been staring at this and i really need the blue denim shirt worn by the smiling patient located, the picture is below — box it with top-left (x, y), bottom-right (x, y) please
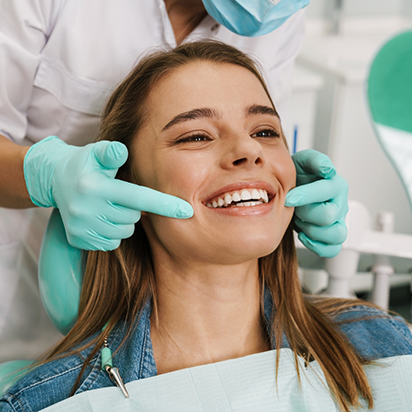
top-left (0, 293), bottom-right (412, 412)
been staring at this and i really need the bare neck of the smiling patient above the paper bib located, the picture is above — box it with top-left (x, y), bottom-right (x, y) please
top-left (151, 261), bottom-right (270, 374)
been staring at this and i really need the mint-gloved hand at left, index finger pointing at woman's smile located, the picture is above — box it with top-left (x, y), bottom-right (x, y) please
top-left (24, 136), bottom-right (193, 250)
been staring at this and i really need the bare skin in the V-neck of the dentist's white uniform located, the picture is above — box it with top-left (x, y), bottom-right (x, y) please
top-left (164, 0), bottom-right (207, 44)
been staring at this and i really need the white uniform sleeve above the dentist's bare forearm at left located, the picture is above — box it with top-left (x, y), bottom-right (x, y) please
top-left (0, 0), bottom-right (64, 143)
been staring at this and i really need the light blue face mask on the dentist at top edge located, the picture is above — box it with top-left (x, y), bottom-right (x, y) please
top-left (202, 0), bottom-right (310, 37)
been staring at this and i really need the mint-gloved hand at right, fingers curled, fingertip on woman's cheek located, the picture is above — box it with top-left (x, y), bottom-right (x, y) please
top-left (285, 150), bottom-right (349, 257)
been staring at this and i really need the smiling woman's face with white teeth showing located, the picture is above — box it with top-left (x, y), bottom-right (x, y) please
top-left (132, 62), bottom-right (295, 264)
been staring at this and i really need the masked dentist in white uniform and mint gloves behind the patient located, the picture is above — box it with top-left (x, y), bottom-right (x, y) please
top-left (0, 0), bottom-right (348, 362)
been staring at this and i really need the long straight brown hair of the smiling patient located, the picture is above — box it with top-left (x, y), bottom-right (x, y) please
top-left (47, 41), bottom-right (373, 411)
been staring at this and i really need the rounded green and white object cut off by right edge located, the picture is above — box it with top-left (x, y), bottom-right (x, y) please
top-left (366, 29), bottom-right (412, 212)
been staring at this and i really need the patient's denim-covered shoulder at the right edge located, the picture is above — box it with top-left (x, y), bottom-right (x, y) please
top-left (333, 304), bottom-right (412, 360)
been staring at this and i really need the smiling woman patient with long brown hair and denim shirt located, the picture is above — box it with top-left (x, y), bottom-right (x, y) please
top-left (0, 42), bottom-right (412, 411)
